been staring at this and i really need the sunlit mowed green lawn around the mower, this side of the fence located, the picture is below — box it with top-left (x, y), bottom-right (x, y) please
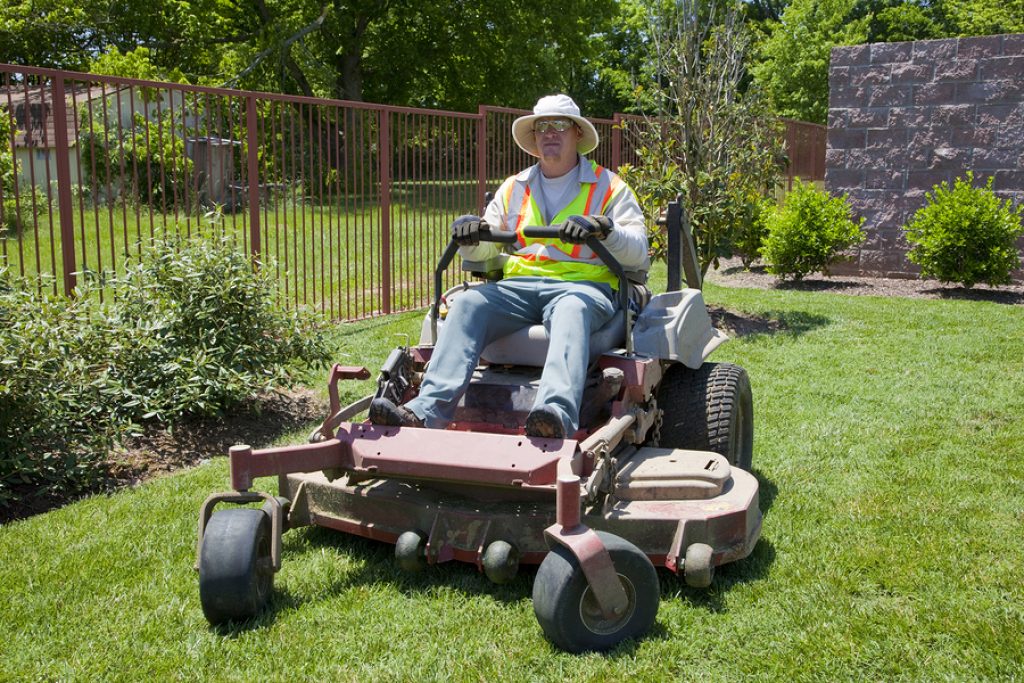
top-left (0, 285), bottom-right (1024, 681)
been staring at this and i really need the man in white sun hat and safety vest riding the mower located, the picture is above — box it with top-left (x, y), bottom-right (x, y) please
top-left (370, 95), bottom-right (650, 438)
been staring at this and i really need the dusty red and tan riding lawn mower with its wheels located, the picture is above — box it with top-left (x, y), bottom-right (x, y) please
top-left (196, 200), bottom-right (761, 651)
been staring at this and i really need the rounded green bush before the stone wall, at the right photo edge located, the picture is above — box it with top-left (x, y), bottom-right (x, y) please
top-left (903, 171), bottom-right (1024, 288)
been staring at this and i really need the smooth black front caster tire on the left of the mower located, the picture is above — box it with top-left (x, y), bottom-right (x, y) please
top-left (199, 508), bottom-right (273, 626)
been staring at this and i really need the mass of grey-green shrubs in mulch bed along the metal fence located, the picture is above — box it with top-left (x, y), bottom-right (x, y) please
top-left (0, 238), bottom-right (328, 506)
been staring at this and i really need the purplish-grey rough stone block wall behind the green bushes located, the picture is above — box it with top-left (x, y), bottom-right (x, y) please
top-left (825, 35), bottom-right (1024, 280)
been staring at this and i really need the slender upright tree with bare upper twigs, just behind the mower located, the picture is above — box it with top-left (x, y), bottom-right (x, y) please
top-left (624, 0), bottom-right (782, 272)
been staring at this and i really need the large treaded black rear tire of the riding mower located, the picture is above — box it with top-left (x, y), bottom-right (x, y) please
top-left (657, 362), bottom-right (754, 471)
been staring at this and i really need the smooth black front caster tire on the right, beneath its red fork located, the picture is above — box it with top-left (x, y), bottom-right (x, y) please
top-left (534, 531), bottom-right (660, 652)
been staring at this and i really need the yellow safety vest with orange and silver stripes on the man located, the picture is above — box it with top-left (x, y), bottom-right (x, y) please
top-left (499, 162), bottom-right (626, 290)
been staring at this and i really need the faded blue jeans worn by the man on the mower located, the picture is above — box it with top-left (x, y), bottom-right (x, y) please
top-left (406, 278), bottom-right (616, 434)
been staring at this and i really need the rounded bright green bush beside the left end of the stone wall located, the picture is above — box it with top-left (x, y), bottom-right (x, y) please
top-left (761, 180), bottom-right (864, 280)
